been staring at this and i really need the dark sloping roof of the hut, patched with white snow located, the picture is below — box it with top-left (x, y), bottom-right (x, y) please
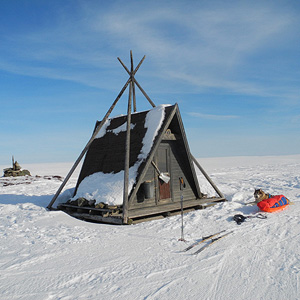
top-left (73, 105), bottom-right (169, 205)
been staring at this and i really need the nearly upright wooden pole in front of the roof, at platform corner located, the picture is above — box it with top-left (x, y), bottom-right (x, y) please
top-left (123, 82), bottom-right (132, 224)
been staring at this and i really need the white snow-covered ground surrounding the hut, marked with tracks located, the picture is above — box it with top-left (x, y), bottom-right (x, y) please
top-left (0, 155), bottom-right (300, 300)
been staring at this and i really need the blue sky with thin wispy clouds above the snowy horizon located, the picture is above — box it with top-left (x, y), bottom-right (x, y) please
top-left (0, 0), bottom-right (300, 165)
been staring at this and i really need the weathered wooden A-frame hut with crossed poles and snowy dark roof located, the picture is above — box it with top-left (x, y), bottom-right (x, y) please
top-left (48, 53), bottom-right (225, 224)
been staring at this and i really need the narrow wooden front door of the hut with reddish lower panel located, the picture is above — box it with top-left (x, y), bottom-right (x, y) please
top-left (157, 144), bottom-right (171, 202)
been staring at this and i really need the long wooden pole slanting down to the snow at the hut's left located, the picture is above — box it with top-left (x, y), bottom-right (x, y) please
top-left (47, 78), bottom-right (131, 209)
